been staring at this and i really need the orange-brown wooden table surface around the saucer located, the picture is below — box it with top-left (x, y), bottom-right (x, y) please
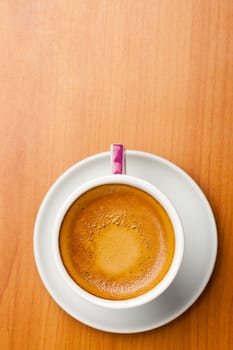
top-left (0, 0), bottom-right (233, 350)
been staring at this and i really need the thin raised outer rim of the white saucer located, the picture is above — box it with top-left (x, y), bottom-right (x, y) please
top-left (33, 150), bottom-right (218, 334)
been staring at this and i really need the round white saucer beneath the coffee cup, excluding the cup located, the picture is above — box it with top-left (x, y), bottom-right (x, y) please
top-left (34, 151), bottom-right (217, 333)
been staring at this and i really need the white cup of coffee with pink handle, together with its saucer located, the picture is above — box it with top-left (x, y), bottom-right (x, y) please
top-left (34, 144), bottom-right (217, 333)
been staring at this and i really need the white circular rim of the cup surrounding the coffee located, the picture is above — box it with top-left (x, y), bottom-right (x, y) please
top-left (52, 174), bottom-right (184, 309)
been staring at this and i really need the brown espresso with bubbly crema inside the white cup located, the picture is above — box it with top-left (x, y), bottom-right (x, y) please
top-left (58, 183), bottom-right (175, 300)
